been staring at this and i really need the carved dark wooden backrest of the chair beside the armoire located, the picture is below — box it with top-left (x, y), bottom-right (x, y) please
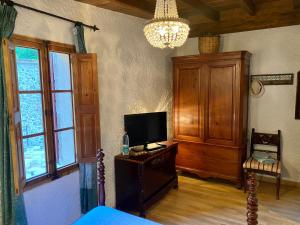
top-left (250, 128), bottom-right (281, 160)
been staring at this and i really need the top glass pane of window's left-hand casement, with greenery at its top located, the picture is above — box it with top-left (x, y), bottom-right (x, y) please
top-left (16, 47), bottom-right (41, 91)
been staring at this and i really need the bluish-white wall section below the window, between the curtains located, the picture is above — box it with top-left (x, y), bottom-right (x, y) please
top-left (24, 172), bottom-right (81, 225)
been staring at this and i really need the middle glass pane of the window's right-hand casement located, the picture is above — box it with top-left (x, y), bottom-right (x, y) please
top-left (52, 93), bottom-right (73, 129)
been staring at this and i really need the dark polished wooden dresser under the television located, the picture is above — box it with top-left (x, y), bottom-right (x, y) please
top-left (115, 142), bottom-right (178, 217)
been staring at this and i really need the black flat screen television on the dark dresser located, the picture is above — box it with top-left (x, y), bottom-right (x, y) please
top-left (124, 112), bottom-right (167, 149)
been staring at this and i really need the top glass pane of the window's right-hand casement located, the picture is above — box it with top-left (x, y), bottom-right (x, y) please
top-left (50, 52), bottom-right (71, 90)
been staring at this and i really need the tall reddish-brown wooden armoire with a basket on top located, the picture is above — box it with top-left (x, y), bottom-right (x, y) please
top-left (173, 51), bottom-right (251, 184)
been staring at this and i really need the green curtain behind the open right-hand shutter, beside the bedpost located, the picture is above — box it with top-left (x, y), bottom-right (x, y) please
top-left (74, 22), bottom-right (98, 213)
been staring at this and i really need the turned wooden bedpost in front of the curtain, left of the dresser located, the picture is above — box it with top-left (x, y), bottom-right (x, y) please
top-left (97, 149), bottom-right (105, 205)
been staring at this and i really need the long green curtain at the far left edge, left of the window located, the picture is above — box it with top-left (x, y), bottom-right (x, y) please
top-left (0, 5), bottom-right (27, 225)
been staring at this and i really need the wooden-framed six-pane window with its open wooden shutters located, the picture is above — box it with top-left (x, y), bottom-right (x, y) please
top-left (2, 35), bottom-right (100, 190)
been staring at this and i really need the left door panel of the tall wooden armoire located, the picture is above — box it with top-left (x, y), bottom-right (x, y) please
top-left (175, 65), bottom-right (203, 141)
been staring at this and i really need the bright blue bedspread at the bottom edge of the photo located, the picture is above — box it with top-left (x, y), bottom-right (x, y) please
top-left (73, 206), bottom-right (161, 225)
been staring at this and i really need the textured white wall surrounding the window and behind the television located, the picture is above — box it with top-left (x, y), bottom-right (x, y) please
top-left (15, 0), bottom-right (172, 225)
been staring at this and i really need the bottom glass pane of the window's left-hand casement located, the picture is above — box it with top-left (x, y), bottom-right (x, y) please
top-left (23, 136), bottom-right (47, 180)
